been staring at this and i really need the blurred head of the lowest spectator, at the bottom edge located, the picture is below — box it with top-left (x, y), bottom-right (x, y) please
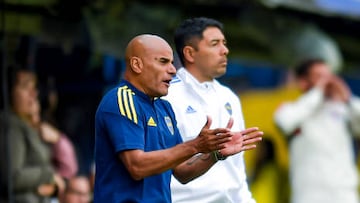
top-left (60, 176), bottom-right (92, 203)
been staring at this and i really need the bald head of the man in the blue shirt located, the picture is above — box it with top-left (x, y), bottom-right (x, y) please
top-left (124, 34), bottom-right (176, 97)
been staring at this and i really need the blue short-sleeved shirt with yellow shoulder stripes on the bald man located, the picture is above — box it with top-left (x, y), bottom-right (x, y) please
top-left (94, 80), bottom-right (182, 203)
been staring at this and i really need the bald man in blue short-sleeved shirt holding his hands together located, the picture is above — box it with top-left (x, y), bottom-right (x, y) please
top-left (94, 34), bottom-right (262, 203)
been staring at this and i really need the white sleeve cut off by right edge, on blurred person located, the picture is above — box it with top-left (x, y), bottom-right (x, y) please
top-left (348, 96), bottom-right (360, 137)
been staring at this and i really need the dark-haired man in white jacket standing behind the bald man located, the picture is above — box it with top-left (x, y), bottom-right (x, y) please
top-left (164, 17), bottom-right (255, 203)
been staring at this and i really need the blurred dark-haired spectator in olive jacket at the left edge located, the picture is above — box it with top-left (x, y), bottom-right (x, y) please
top-left (0, 67), bottom-right (64, 203)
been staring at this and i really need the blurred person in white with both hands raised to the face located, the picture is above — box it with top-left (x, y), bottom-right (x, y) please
top-left (274, 59), bottom-right (360, 203)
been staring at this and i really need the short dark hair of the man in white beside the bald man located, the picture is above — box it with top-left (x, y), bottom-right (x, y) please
top-left (174, 17), bottom-right (224, 64)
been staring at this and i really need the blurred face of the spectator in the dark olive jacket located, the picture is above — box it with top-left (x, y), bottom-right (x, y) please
top-left (11, 71), bottom-right (38, 119)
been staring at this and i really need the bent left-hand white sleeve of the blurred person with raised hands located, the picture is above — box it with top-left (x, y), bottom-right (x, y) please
top-left (274, 88), bottom-right (324, 135)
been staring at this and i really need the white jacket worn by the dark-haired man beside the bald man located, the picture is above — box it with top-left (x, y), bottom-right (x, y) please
top-left (164, 68), bottom-right (255, 203)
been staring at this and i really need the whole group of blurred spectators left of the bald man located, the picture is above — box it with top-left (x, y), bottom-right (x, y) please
top-left (0, 66), bottom-right (92, 203)
